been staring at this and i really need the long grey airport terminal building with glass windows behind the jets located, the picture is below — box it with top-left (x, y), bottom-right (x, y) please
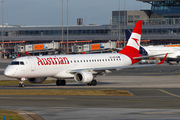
top-left (0, 0), bottom-right (180, 52)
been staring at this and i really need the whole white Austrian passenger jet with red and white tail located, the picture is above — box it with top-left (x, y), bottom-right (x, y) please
top-left (4, 21), bottom-right (167, 87)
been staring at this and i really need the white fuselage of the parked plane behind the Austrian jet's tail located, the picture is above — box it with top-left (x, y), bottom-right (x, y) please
top-left (143, 46), bottom-right (180, 58)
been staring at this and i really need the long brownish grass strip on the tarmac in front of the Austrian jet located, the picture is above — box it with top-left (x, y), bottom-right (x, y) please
top-left (0, 89), bottom-right (133, 96)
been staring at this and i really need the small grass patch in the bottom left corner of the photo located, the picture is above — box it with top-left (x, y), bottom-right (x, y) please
top-left (0, 110), bottom-right (25, 120)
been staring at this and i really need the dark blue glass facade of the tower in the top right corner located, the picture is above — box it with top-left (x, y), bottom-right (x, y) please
top-left (151, 0), bottom-right (180, 18)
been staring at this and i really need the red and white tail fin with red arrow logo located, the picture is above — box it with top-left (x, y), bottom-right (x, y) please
top-left (119, 20), bottom-right (143, 54)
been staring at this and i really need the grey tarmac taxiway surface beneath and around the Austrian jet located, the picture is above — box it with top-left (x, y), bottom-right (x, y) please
top-left (0, 61), bottom-right (180, 120)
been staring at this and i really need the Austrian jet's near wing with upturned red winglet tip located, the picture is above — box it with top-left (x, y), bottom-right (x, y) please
top-left (69, 53), bottom-right (168, 74)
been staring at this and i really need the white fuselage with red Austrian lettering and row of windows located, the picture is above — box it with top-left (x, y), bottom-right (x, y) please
top-left (4, 53), bottom-right (132, 78)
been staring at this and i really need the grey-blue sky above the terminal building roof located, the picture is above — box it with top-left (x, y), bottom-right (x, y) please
top-left (0, 0), bottom-right (151, 25)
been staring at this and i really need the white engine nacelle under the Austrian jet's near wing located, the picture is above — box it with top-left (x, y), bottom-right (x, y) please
top-left (74, 72), bottom-right (93, 83)
